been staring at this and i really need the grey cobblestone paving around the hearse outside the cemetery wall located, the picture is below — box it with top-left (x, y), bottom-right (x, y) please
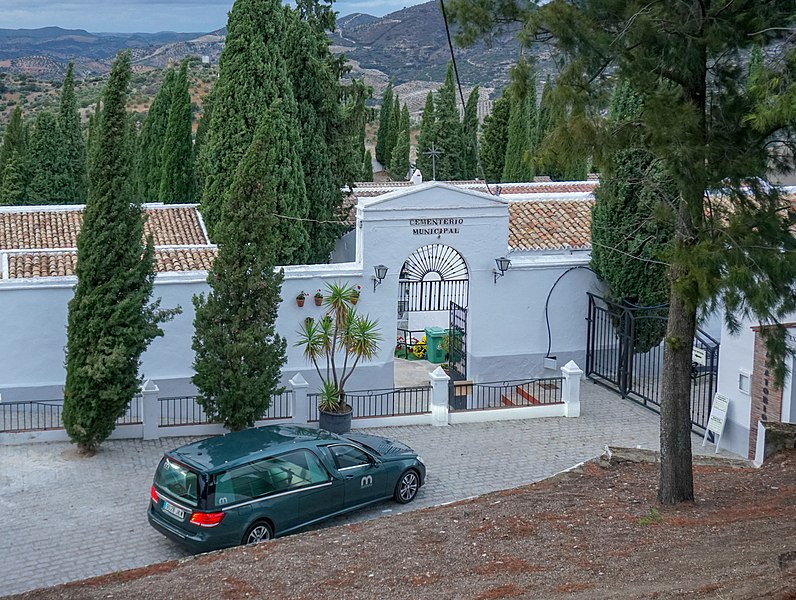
top-left (0, 381), bottom-right (732, 595)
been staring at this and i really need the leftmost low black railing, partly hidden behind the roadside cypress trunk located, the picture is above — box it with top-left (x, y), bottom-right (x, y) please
top-left (0, 395), bottom-right (143, 433)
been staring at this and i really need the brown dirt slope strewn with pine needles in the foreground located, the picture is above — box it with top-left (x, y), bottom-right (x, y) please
top-left (7, 451), bottom-right (796, 600)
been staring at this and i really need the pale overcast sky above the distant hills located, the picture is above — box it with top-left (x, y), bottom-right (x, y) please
top-left (0, 0), bottom-right (425, 32)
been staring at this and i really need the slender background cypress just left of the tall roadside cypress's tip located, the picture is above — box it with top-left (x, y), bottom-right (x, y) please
top-left (58, 62), bottom-right (88, 204)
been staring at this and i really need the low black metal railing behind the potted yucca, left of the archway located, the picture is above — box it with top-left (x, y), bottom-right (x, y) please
top-left (307, 385), bottom-right (431, 423)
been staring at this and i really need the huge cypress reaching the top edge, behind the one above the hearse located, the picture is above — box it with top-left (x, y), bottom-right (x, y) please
top-left (199, 0), bottom-right (296, 237)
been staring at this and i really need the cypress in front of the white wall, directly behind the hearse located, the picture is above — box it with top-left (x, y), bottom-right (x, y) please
top-left (193, 101), bottom-right (290, 431)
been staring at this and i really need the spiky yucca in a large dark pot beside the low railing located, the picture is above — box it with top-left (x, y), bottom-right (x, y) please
top-left (295, 283), bottom-right (381, 433)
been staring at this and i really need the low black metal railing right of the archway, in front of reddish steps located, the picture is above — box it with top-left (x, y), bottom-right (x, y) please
top-left (450, 377), bottom-right (564, 411)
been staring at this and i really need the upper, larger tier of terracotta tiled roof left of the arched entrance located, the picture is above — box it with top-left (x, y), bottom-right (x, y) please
top-left (0, 206), bottom-right (209, 250)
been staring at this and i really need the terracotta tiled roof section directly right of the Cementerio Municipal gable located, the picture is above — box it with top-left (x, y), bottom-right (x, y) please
top-left (509, 200), bottom-right (594, 250)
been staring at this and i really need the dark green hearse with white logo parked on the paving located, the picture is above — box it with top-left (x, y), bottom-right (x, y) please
top-left (147, 425), bottom-right (426, 552)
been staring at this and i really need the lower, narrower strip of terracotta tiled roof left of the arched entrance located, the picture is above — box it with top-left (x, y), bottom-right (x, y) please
top-left (8, 248), bottom-right (216, 279)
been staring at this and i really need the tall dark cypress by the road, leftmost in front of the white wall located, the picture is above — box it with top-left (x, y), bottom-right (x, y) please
top-left (63, 52), bottom-right (175, 454)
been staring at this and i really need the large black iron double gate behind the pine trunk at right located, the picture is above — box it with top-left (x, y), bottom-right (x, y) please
top-left (586, 293), bottom-right (719, 433)
